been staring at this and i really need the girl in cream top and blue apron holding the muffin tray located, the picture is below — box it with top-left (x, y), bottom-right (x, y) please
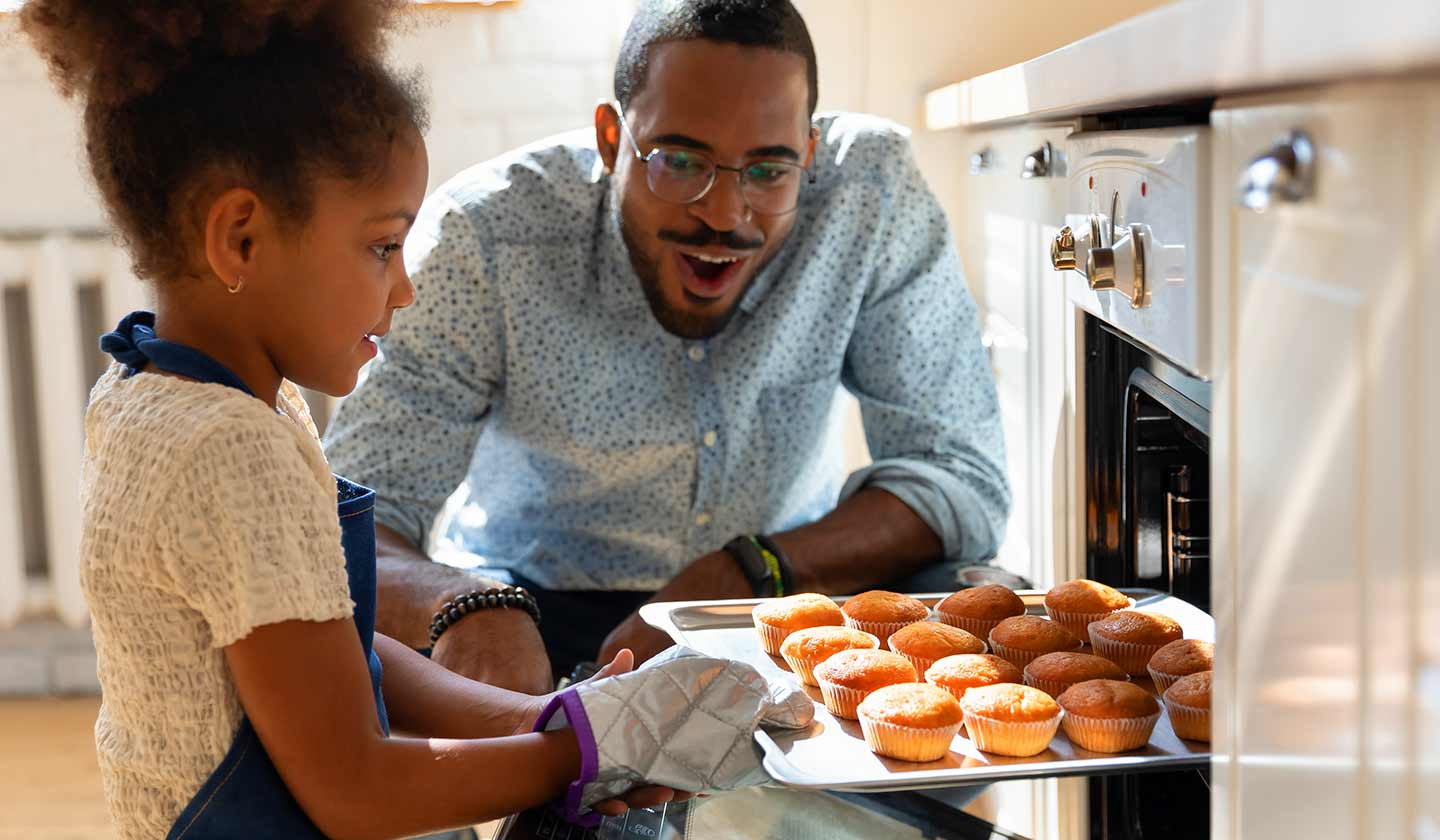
top-left (20, 0), bottom-right (812, 839)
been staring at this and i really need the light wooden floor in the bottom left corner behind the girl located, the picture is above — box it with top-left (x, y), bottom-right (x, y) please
top-left (0, 697), bottom-right (115, 840)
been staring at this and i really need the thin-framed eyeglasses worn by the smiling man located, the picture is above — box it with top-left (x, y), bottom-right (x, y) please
top-left (615, 105), bottom-right (815, 216)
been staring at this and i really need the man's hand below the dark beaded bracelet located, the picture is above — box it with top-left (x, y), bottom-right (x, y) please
top-left (431, 608), bottom-right (554, 694)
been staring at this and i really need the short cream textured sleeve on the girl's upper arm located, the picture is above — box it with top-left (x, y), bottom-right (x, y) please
top-left (163, 415), bottom-right (354, 647)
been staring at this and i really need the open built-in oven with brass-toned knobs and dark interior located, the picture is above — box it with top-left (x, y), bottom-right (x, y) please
top-left (1051, 124), bottom-right (1212, 840)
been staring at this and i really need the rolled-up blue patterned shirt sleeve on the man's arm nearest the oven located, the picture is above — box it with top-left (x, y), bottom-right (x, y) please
top-left (841, 137), bottom-right (1011, 562)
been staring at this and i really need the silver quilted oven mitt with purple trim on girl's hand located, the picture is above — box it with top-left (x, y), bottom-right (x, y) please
top-left (534, 645), bottom-right (815, 826)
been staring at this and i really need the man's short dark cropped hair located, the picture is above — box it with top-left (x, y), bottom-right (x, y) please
top-left (615, 0), bottom-right (819, 115)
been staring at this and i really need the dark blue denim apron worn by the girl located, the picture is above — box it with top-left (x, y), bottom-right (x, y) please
top-left (99, 311), bottom-right (390, 840)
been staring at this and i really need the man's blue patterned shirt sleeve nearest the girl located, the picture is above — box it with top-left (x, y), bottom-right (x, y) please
top-left (325, 193), bottom-right (505, 546)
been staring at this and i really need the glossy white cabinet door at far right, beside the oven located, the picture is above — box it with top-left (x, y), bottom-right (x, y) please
top-left (1214, 84), bottom-right (1440, 840)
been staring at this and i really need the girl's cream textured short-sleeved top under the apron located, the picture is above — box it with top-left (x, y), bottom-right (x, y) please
top-left (81, 363), bottom-right (354, 840)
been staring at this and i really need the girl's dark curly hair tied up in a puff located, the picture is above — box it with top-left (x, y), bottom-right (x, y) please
top-left (20, 0), bottom-right (426, 280)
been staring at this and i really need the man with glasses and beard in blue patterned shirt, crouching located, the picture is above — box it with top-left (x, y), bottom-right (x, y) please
top-left (328, 0), bottom-right (1009, 692)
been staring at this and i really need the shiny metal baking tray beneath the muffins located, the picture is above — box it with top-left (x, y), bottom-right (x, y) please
top-left (639, 589), bottom-right (1215, 792)
